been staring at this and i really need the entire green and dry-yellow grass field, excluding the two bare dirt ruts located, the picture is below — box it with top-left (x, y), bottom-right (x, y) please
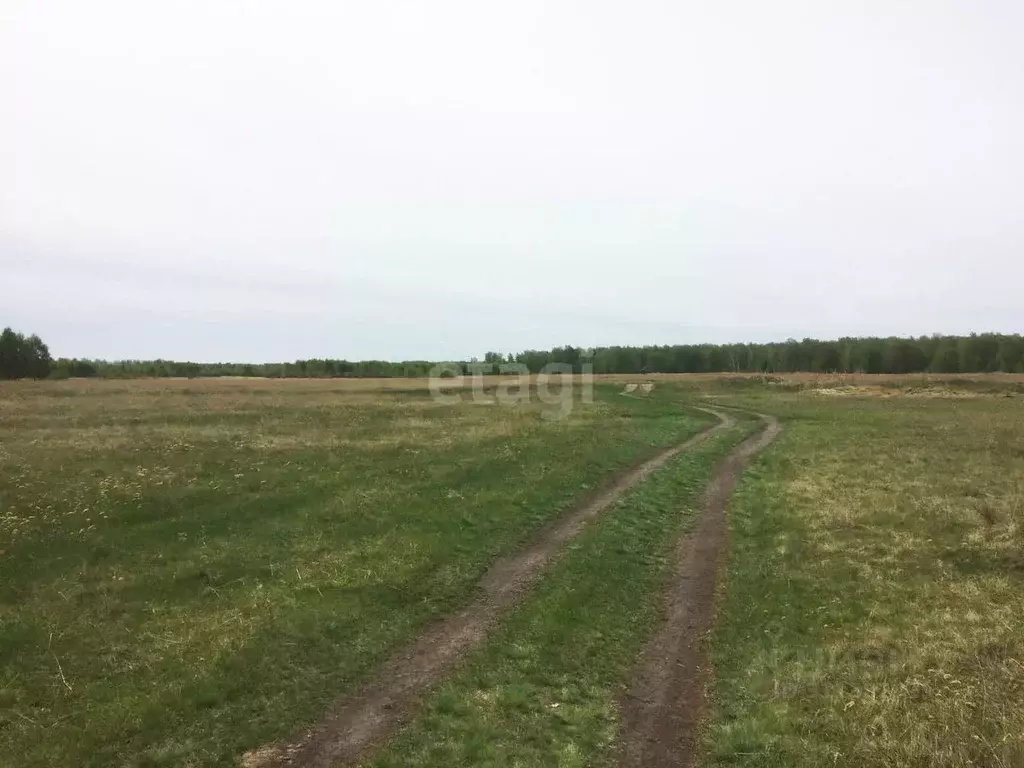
top-left (0, 376), bottom-right (1024, 768)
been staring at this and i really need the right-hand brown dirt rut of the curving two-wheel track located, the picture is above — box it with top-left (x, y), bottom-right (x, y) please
top-left (618, 414), bottom-right (782, 768)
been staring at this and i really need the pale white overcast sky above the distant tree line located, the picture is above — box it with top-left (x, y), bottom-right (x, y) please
top-left (0, 0), bottom-right (1024, 361)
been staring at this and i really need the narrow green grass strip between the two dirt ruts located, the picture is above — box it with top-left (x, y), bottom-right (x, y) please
top-left (372, 422), bottom-right (753, 768)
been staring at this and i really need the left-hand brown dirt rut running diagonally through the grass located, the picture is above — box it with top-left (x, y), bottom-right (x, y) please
top-left (243, 407), bottom-right (735, 768)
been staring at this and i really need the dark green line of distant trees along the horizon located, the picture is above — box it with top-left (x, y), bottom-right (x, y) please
top-left (0, 328), bottom-right (1024, 379)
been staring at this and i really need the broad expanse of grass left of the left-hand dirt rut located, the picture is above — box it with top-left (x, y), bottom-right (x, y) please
top-left (0, 381), bottom-right (710, 766)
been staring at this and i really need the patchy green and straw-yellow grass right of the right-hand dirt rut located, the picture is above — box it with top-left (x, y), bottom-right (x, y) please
top-left (705, 393), bottom-right (1024, 768)
